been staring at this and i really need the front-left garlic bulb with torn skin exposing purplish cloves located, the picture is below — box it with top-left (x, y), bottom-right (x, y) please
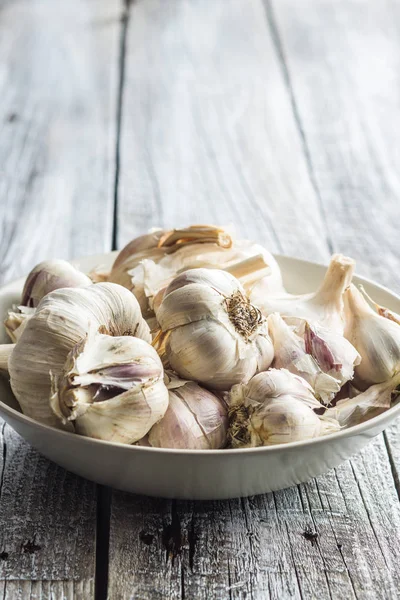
top-left (50, 333), bottom-right (168, 444)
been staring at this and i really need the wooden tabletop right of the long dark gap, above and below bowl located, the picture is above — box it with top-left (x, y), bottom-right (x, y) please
top-left (109, 0), bottom-right (400, 600)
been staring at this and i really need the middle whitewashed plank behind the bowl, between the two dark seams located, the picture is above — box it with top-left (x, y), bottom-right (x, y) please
top-left (118, 0), bottom-right (332, 257)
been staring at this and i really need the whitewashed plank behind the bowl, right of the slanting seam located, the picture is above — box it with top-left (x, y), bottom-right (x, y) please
top-left (265, 0), bottom-right (400, 290)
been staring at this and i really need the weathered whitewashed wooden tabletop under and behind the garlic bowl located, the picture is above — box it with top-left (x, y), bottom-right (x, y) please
top-left (0, 0), bottom-right (400, 600)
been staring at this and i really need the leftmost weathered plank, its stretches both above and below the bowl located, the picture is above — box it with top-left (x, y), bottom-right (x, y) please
top-left (0, 0), bottom-right (122, 599)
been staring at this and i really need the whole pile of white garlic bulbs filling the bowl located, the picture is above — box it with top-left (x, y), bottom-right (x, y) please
top-left (0, 225), bottom-right (400, 450)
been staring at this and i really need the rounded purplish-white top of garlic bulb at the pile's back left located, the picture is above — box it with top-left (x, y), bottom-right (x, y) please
top-left (21, 260), bottom-right (92, 308)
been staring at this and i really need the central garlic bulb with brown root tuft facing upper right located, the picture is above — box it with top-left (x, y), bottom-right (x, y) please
top-left (156, 269), bottom-right (273, 390)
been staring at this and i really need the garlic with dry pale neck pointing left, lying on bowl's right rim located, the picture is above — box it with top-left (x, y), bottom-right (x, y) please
top-left (324, 373), bottom-right (400, 427)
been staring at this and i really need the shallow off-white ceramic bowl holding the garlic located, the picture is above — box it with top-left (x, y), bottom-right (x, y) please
top-left (0, 254), bottom-right (400, 499)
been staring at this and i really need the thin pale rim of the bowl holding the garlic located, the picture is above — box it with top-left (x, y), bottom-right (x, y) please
top-left (0, 251), bottom-right (400, 457)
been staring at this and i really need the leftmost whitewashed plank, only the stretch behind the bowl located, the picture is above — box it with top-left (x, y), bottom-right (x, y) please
top-left (0, 0), bottom-right (122, 281)
